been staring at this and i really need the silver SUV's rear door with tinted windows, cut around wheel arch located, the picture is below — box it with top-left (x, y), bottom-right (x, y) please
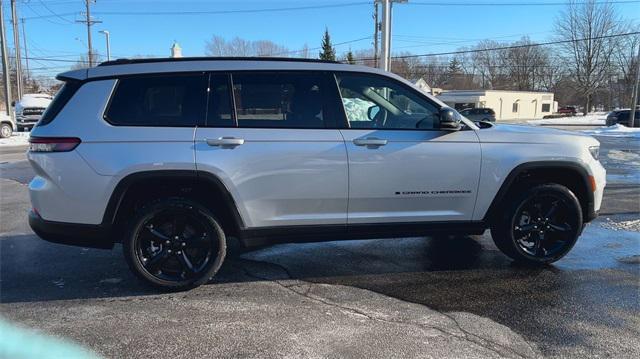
top-left (195, 71), bottom-right (348, 228)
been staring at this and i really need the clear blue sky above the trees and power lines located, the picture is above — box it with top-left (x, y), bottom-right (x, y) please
top-left (2, 0), bottom-right (640, 76)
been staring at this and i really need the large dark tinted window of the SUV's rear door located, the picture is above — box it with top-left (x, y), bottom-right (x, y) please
top-left (233, 73), bottom-right (327, 128)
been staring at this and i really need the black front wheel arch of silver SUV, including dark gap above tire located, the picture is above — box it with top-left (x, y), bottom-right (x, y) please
top-left (483, 161), bottom-right (596, 223)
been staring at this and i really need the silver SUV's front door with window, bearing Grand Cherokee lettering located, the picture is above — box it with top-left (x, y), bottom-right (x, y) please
top-left (336, 73), bottom-right (481, 224)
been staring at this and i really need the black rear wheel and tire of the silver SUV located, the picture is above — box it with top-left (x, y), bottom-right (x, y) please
top-left (122, 198), bottom-right (227, 291)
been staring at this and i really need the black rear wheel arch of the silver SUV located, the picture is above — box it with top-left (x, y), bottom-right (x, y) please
top-left (102, 170), bottom-right (245, 240)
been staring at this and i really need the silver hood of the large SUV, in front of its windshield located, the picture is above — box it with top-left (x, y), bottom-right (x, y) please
top-left (476, 124), bottom-right (599, 145)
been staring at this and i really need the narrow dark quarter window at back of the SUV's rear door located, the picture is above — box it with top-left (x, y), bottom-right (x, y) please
top-left (207, 74), bottom-right (235, 127)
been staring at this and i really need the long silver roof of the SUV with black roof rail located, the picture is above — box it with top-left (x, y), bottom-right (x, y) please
top-left (57, 57), bottom-right (382, 81)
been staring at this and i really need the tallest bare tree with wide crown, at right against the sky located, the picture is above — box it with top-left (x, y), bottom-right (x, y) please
top-left (556, 0), bottom-right (620, 114)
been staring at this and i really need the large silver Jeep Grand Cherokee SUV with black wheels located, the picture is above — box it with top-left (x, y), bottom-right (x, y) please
top-left (28, 58), bottom-right (605, 290)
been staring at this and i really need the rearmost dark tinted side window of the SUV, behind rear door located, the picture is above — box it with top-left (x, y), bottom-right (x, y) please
top-left (106, 74), bottom-right (207, 127)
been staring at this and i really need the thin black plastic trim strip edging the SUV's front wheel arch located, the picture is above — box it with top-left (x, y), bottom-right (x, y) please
top-left (483, 161), bottom-right (598, 223)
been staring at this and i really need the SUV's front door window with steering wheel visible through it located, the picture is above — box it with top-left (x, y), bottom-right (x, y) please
top-left (336, 73), bottom-right (439, 129)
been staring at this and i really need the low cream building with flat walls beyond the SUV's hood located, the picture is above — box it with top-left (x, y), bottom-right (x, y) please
top-left (438, 90), bottom-right (558, 121)
